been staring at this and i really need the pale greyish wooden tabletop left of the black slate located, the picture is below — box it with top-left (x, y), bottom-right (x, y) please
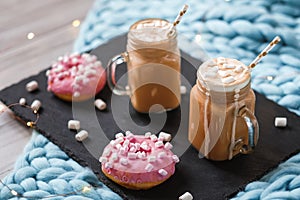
top-left (0, 0), bottom-right (93, 178)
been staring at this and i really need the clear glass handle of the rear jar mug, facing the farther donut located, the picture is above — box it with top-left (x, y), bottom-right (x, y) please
top-left (107, 52), bottom-right (129, 95)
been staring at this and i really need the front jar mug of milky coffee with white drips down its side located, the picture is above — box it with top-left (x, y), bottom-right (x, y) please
top-left (189, 58), bottom-right (258, 160)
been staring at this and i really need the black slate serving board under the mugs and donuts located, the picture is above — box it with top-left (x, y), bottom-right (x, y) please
top-left (0, 35), bottom-right (300, 200)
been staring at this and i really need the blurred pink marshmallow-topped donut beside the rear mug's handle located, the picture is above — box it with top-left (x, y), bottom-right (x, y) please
top-left (46, 53), bottom-right (106, 101)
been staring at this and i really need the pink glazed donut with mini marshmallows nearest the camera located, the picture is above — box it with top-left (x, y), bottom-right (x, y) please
top-left (99, 131), bottom-right (179, 190)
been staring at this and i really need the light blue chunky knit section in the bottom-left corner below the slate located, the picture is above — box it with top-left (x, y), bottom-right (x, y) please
top-left (0, 131), bottom-right (121, 200)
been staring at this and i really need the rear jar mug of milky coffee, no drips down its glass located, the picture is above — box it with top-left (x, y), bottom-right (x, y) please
top-left (109, 19), bottom-right (180, 113)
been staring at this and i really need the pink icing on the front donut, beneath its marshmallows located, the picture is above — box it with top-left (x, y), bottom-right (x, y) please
top-left (102, 135), bottom-right (178, 183)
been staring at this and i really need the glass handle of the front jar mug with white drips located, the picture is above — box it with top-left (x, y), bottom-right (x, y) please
top-left (235, 105), bottom-right (259, 154)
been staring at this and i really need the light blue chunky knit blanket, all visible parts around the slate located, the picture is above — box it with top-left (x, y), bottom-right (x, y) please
top-left (0, 0), bottom-right (300, 200)
